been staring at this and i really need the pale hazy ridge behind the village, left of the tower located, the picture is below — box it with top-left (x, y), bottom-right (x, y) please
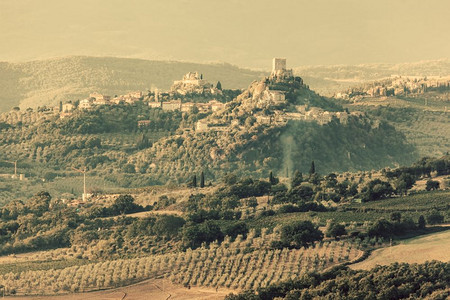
top-left (0, 56), bottom-right (263, 112)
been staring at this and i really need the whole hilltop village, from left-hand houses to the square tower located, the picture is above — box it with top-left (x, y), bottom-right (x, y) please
top-left (0, 58), bottom-right (362, 132)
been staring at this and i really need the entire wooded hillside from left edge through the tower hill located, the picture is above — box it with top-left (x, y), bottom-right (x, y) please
top-left (0, 68), bottom-right (418, 191)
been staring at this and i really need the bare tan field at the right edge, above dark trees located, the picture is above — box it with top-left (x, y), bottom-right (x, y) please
top-left (351, 230), bottom-right (450, 270)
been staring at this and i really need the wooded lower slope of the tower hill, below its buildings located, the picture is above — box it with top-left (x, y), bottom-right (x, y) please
top-left (136, 118), bottom-right (415, 183)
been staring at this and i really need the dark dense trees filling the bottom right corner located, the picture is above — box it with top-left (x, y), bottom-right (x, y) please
top-left (226, 261), bottom-right (450, 300)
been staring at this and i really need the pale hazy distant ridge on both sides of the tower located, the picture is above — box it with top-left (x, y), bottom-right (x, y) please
top-left (0, 56), bottom-right (450, 112)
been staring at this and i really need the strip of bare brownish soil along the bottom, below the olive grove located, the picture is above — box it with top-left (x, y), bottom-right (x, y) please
top-left (4, 279), bottom-right (235, 300)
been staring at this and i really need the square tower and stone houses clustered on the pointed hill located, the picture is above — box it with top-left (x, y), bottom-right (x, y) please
top-left (196, 58), bottom-right (362, 132)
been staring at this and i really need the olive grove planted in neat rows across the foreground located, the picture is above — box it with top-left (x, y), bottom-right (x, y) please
top-left (0, 233), bottom-right (362, 299)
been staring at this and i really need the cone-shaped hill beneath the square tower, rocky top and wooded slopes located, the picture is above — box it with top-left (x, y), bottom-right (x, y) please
top-left (127, 71), bottom-right (417, 182)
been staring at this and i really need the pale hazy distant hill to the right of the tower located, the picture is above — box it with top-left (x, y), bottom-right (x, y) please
top-left (294, 59), bottom-right (450, 95)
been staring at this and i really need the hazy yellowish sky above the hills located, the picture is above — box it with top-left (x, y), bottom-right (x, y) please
top-left (0, 0), bottom-right (450, 68)
